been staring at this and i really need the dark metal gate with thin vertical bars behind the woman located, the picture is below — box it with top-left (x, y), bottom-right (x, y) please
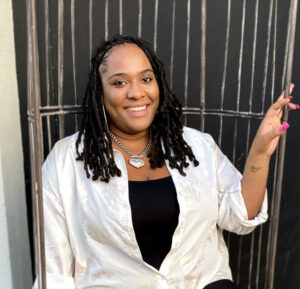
top-left (27, 0), bottom-right (297, 289)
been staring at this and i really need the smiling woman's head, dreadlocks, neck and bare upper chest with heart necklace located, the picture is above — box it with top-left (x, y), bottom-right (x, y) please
top-left (76, 35), bottom-right (198, 181)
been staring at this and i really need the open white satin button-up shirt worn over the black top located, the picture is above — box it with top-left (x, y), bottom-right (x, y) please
top-left (34, 127), bottom-right (268, 289)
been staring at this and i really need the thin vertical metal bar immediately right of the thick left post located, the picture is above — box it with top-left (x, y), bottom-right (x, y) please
top-left (44, 0), bottom-right (52, 150)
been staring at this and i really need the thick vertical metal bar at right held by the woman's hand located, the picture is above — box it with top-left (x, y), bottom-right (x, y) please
top-left (268, 0), bottom-right (298, 289)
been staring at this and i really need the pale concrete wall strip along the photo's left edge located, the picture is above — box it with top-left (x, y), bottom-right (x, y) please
top-left (0, 0), bottom-right (32, 289)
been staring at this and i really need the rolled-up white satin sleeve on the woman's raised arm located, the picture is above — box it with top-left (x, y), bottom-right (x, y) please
top-left (215, 140), bottom-right (268, 235)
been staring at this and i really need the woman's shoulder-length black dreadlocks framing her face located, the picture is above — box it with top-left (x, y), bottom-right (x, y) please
top-left (76, 35), bottom-right (199, 182)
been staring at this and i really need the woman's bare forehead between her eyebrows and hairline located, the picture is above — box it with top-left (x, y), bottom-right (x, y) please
top-left (100, 43), bottom-right (152, 73)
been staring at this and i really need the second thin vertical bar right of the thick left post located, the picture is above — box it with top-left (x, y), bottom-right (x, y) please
top-left (58, 1), bottom-right (65, 138)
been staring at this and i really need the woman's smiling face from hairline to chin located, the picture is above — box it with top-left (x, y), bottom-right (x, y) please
top-left (99, 43), bottom-right (159, 134)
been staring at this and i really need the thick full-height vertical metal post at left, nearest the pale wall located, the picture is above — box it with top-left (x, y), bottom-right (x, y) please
top-left (27, 0), bottom-right (46, 289)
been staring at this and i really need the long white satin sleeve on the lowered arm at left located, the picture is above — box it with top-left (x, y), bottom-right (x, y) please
top-left (33, 147), bottom-right (75, 289)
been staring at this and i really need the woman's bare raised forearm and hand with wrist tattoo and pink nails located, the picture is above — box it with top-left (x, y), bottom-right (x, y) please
top-left (241, 84), bottom-right (299, 220)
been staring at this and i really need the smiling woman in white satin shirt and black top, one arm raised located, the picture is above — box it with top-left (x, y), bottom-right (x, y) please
top-left (35, 35), bottom-right (298, 289)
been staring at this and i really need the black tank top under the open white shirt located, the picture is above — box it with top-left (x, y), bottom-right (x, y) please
top-left (129, 176), bottom-right (179, 270)
